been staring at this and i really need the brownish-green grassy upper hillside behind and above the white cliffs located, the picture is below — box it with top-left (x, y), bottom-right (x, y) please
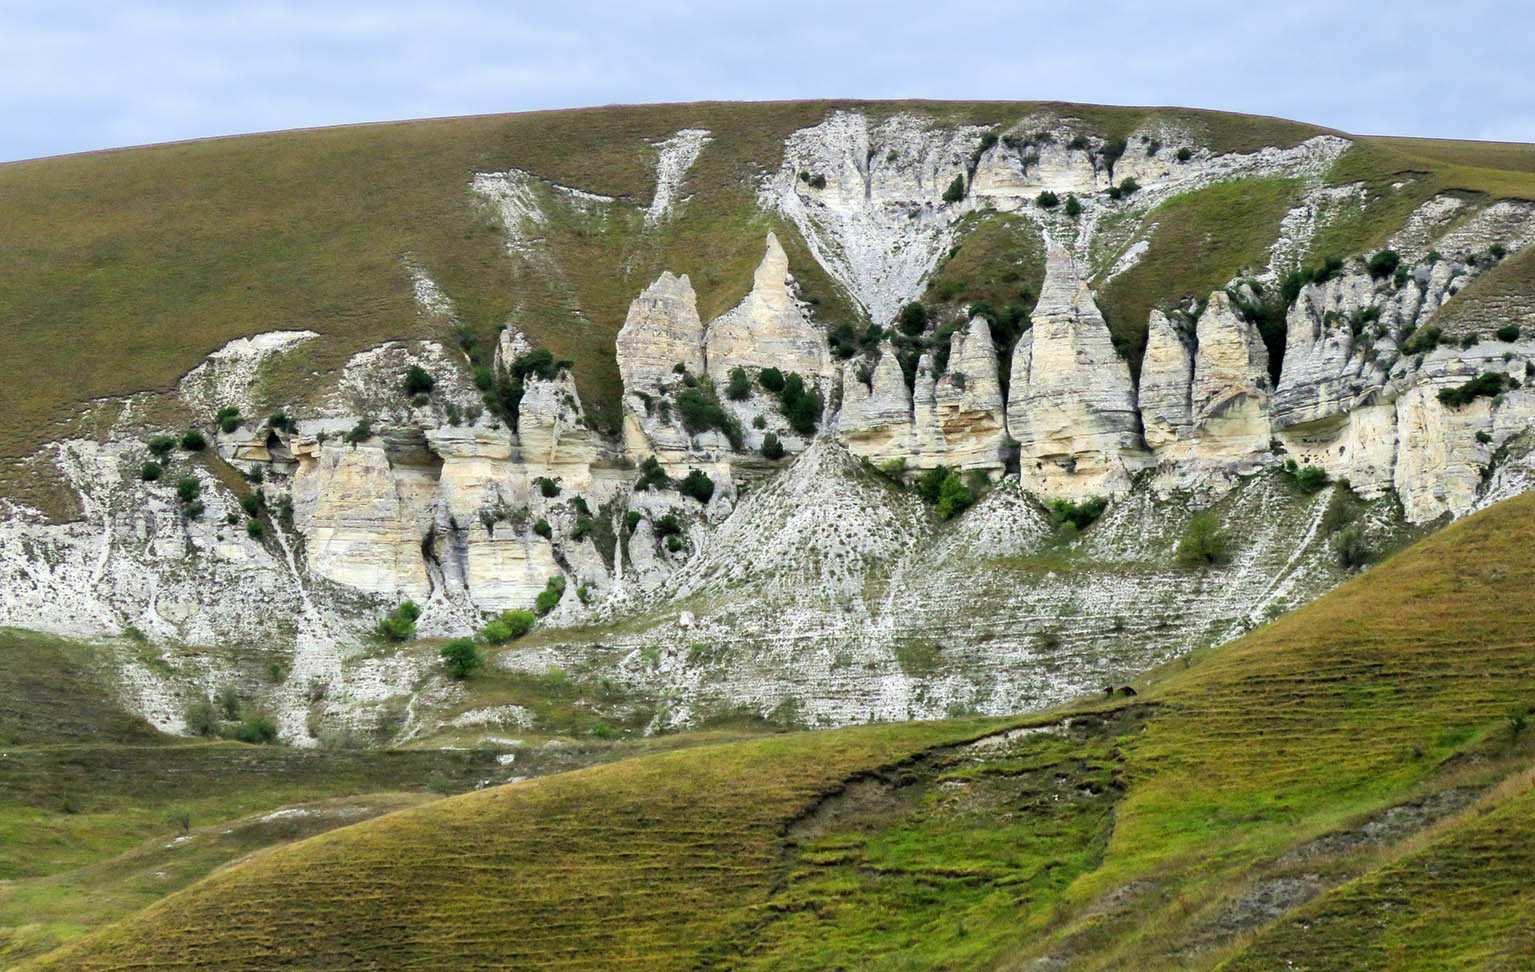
top-left (9, 101), bottom-right (1535, 507)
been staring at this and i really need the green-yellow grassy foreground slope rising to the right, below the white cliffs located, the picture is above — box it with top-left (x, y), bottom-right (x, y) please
top-left (20, 496), bottom-right (1535, 970)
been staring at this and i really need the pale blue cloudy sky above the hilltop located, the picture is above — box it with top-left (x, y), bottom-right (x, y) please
top-left (0, 0), bottom-right (1535, 161)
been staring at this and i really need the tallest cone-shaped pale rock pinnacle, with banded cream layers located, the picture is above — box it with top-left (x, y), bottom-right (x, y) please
top-left (1007, 244), bottom-right (1145, 496)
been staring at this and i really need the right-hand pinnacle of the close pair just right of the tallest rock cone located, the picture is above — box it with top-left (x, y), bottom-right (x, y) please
top-left (1190, 290), bottom-right (1269, 459)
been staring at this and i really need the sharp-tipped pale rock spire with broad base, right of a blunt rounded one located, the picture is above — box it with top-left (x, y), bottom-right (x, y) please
top-left (703, 233), bottom-right (830, 388)
